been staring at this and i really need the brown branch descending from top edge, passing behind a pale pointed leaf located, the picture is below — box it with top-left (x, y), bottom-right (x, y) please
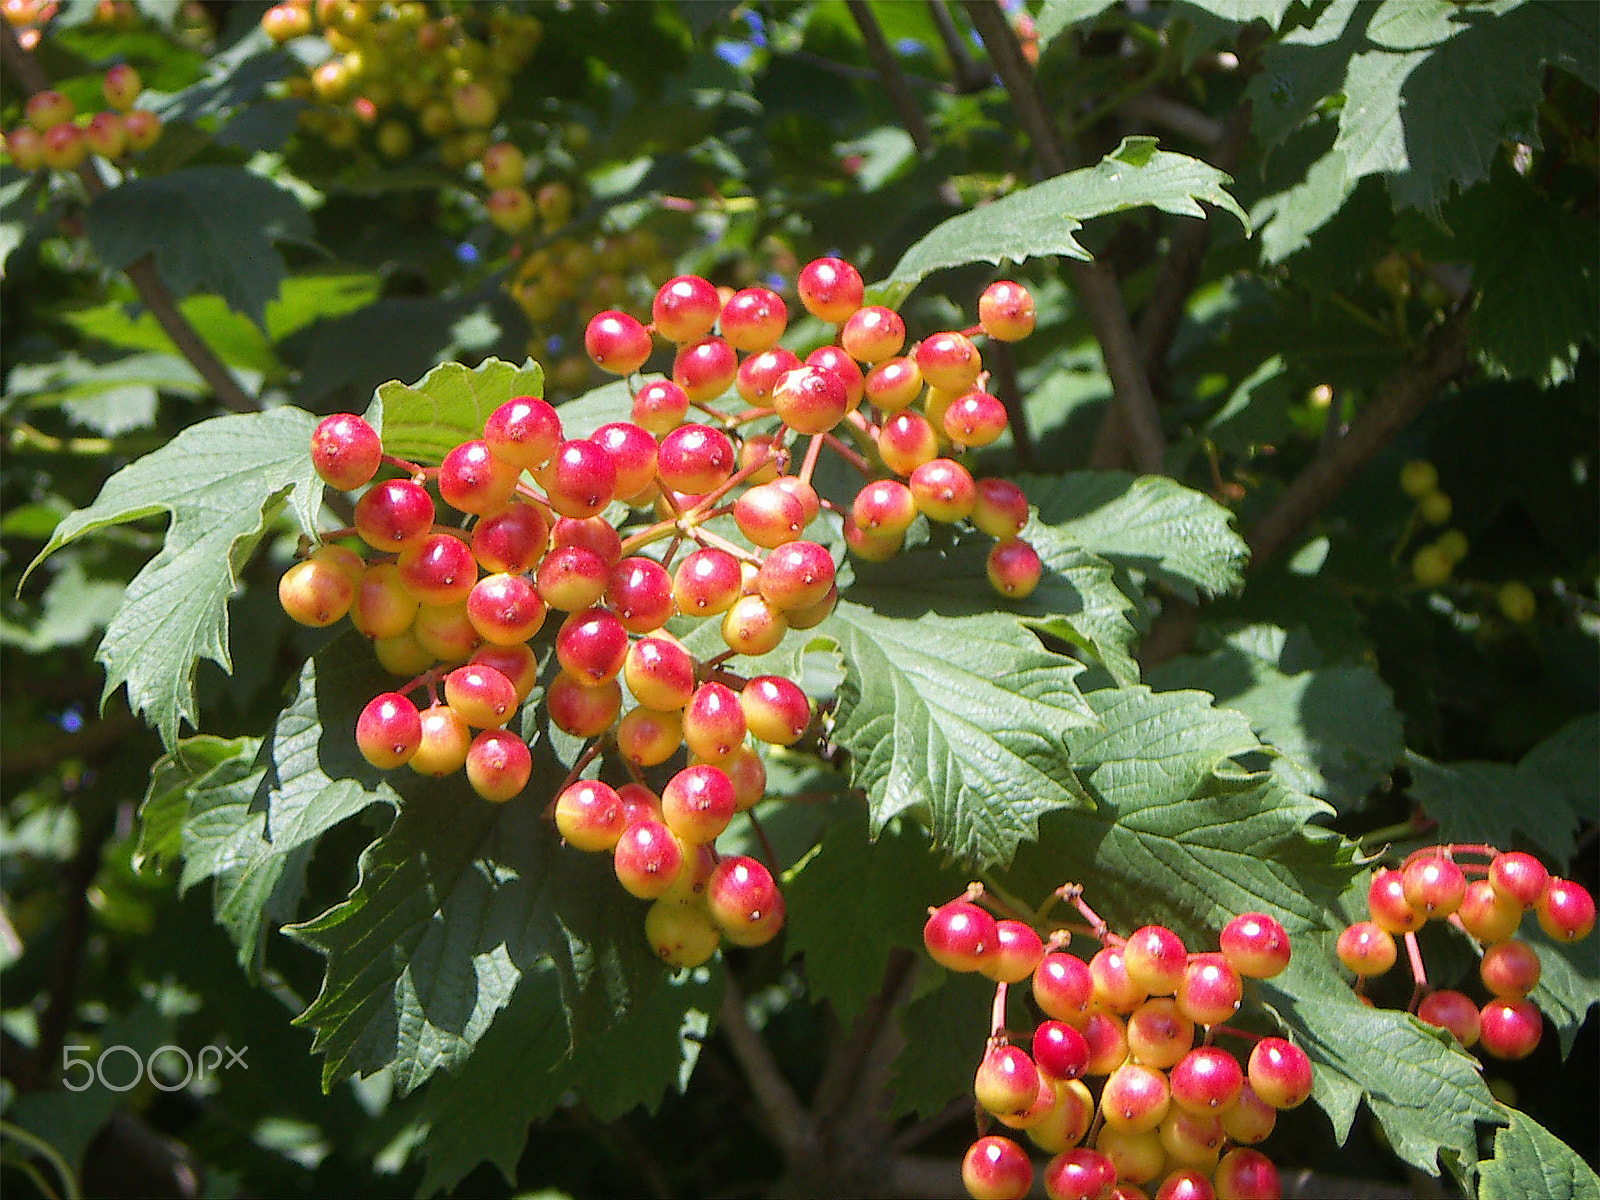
top-left (965, 0), bottom-right (1166, 474)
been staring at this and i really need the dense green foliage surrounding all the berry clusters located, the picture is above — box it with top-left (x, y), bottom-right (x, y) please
top-left (0, 0), bottom-right (1600, 1200)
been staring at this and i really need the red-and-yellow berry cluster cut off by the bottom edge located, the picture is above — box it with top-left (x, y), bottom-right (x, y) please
top-left (923, 883), bottom-right (1312, 1200)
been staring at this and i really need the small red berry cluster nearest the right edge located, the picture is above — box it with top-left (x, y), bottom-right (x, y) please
top-left (1336, 845), bottom-right (1595, 1059)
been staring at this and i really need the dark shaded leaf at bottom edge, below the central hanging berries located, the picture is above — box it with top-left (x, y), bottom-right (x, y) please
top-left (418, 966), bottom-right (723, 1195)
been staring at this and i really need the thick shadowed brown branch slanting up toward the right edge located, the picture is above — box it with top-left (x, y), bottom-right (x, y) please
top-left (1245, 309), bottom-right (1470, 570)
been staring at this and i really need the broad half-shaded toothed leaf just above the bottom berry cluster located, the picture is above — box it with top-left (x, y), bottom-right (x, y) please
top-left (1005, 686), bottom-right (1355, 941)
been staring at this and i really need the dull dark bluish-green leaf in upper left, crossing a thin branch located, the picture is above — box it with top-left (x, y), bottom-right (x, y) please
top-left (86, 166), bottom-right (312, 328)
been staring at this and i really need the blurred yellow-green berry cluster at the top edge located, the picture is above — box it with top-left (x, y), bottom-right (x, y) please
top-left (261, 0), bottom-right (542, 170)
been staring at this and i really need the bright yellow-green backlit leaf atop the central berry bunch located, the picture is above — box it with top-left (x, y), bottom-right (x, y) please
top-left (366, 358), bottom-right (544, 462)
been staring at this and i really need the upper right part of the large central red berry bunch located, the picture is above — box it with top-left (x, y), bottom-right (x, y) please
top-left (584, 258), bottom-right (1043, 597)
